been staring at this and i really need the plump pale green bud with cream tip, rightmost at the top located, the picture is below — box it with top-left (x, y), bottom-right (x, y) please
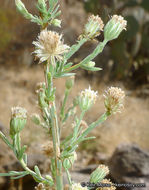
top-left (104, 15), bottom-right (127, 41)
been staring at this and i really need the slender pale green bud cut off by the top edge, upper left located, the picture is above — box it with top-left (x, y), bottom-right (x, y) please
top-left (15, 0), bottom-right (33, 19)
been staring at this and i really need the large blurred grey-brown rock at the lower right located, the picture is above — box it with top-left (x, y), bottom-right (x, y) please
top-left (108, 144), bottom-right (149, 190)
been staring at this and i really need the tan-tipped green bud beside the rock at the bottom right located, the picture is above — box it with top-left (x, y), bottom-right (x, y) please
top-left (90, 165), bottom-right (109, 183)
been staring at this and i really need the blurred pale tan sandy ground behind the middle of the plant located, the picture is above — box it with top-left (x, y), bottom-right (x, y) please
top-left (0, 65), bottom-right (149, 155)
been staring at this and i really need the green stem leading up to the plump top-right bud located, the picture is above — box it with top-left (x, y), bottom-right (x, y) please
top-left (64, 40), bottom-right (107, 73)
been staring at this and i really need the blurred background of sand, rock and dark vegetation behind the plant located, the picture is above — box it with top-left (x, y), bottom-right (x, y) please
top-left (0, 0), bottom-right (149, 190)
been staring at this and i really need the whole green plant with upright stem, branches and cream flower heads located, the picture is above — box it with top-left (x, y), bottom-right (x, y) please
top-left (0, 0), bottom-right (127, 190)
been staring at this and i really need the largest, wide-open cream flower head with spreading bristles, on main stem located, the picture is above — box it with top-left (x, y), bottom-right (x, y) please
top-left (33, 29), bottom-right (69, 63)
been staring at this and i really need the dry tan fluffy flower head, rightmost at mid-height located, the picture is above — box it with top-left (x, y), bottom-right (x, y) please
top-left (103, 87), bottom-right (125, 114)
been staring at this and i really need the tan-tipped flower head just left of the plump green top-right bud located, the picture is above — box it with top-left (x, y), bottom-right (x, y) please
top-left (84, 15), bottom-right (104, 38)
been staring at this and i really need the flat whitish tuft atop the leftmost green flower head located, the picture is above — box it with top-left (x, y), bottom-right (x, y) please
top-left (11, 107), bottom-right (27, 119)
